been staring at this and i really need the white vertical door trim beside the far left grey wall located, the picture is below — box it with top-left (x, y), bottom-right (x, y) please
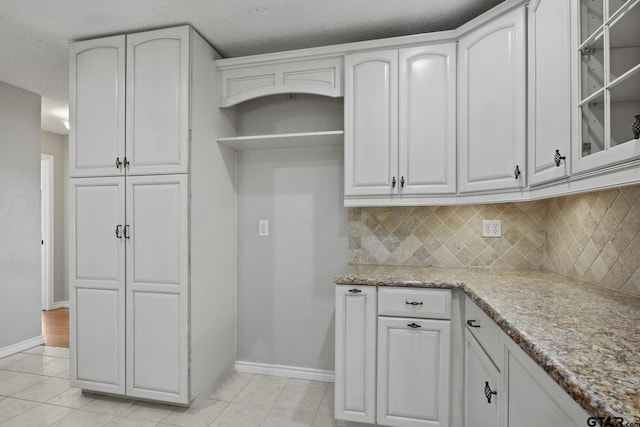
top-left (40, 154), bottom-right (55, 310)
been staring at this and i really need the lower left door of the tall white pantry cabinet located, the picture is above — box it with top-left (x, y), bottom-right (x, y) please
top-left (69, 177), bottom-right (125, 394)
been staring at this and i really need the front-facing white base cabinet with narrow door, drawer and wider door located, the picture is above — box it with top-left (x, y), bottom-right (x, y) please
top-left (335, 285), bottom-right (452, 427)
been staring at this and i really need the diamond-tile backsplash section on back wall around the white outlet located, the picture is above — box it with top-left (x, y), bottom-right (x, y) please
top-left (349, 202), bottom-right (546, 269)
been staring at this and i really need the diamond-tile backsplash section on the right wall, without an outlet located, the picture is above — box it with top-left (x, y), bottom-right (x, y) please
top-left (545, 185), bottom-right (640, 296)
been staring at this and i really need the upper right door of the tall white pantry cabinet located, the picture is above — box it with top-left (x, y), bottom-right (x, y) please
top-left (127, 26), bottom-right (190, 175)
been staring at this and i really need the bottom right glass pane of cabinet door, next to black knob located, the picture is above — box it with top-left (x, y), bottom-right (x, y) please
top-left (610, 70), bottom-right (640, 147)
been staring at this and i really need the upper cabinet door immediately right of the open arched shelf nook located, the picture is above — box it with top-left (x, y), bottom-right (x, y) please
top-left (344, 49), bottom-right (400, 196)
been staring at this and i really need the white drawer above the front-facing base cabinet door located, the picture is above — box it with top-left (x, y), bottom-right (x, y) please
top-left (378, 287), bottom-right (451, 319)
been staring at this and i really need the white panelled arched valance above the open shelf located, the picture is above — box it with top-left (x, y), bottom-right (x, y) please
top-left (220, 56), bottom-right (343, 107)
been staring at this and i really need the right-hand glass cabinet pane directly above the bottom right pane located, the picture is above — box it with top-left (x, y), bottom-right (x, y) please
top-left (609, 3), bottom-right (640, 81)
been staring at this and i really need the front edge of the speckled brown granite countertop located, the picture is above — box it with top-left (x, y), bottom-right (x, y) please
top-left (334, 270), bottom-right (620, 417)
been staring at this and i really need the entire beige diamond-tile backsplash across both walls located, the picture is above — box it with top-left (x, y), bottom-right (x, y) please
top-left (349, 185), bottom-right (640, 296)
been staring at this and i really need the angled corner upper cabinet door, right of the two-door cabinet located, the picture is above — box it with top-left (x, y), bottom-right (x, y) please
top-left (458, 7), bottom-right (526, 192)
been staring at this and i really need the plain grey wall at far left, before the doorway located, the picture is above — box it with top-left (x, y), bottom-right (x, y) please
top-left (0, 82), bottom-right (42, 353)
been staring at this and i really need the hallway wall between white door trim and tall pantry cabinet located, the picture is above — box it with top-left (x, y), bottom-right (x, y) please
top-left (40, 131), bottom-right (69, 302)
